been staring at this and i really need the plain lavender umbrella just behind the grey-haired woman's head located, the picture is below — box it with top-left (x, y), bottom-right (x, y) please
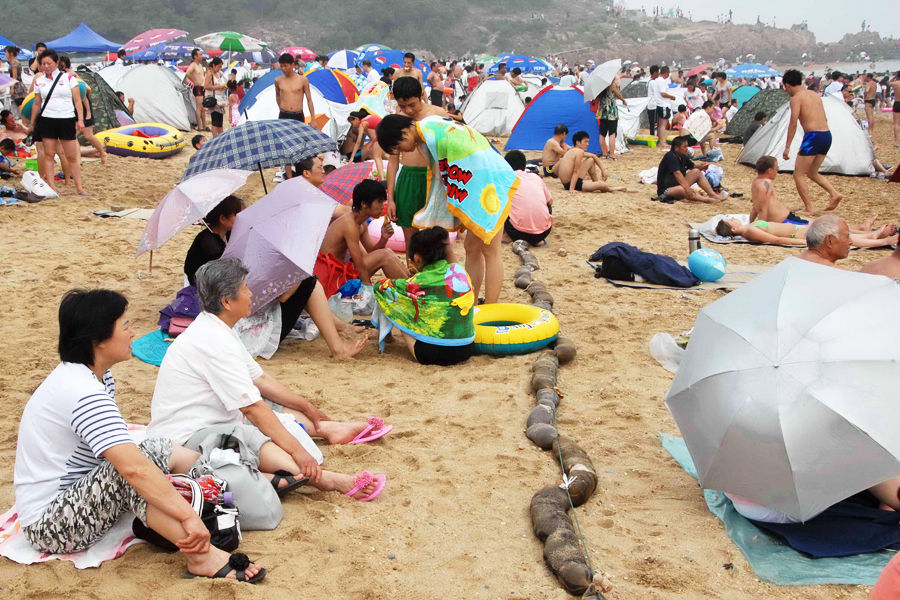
top-left (222, 177), bottom-right (337, 312)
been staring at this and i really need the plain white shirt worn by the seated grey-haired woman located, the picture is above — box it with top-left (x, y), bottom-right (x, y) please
top-left (147, 312), bottom-right (263, 444)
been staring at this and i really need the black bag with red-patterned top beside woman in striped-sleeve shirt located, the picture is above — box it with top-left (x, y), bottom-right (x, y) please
top-left (131, 474), bottom-right (241, 552)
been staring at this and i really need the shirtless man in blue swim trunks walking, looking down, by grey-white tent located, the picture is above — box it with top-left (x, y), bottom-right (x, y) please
top-left (782, 69), bottom-right (843, 214)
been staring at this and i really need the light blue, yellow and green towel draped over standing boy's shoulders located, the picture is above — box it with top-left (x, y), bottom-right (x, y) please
top-left (413, 116), bottom-right (519, 243)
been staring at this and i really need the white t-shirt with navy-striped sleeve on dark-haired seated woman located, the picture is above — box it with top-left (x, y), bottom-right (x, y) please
top-left (13, 360), bottom-right (134, 525)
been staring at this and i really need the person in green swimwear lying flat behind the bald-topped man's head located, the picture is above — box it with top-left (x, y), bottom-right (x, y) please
top-left (716, 218), bottom-right (897, 248)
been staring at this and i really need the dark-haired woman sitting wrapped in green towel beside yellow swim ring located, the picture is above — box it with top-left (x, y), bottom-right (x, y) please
top-left (372, 227), bottom-right (475, 366)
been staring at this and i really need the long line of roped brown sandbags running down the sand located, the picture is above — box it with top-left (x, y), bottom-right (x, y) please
top-left (512, 241), bottom-right (612, 600)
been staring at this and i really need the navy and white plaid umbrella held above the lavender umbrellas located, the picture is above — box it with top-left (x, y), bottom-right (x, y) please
top-left (181, 119), bottom-right (337, 183)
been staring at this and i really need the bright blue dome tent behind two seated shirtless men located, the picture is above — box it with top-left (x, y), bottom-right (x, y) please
top-left (506, 87), bottom-right (600, 154)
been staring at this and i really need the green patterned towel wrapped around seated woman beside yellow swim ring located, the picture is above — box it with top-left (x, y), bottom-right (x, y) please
top-left (372, 260), bottom-right (475, 352)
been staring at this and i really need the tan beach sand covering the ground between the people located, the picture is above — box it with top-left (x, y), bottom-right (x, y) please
top-left (0, 115), bottom-right (900, 600)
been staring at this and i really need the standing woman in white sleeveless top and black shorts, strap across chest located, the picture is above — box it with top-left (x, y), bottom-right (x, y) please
top-left (29, 50), bottom-right (88, 196)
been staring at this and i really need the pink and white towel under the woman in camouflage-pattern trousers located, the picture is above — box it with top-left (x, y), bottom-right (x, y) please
top-left (0, 423), bottom-right (147, 569)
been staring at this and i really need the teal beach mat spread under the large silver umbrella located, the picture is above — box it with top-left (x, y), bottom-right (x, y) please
top-left (659, 433), bottom-right (896, 585)
